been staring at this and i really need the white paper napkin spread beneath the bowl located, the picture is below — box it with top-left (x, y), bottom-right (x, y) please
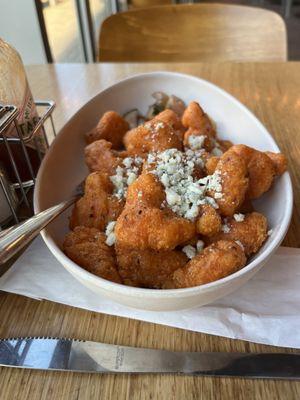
top-left (0, 237), bottom-right (300, 348)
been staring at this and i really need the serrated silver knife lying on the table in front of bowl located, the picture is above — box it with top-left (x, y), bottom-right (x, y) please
top-left (0, 337), bottom-right (300, 379)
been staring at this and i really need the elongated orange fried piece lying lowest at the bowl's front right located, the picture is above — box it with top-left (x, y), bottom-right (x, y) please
top-left (165, 240), bottom-right (246, 289)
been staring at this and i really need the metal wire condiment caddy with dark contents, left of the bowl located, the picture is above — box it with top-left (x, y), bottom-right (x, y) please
top-left (0, 101), bottom-right (56, 229)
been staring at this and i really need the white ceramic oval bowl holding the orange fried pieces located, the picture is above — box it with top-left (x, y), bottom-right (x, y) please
top-left (34, 72), bottom-right (293, 311)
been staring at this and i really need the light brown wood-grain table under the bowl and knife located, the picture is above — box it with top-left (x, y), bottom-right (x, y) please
top-left (0, 63), bottom-right (300, 400)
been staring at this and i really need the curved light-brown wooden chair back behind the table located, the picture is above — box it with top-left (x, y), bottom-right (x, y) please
top-left (98, 3), bottom-right (287, 62)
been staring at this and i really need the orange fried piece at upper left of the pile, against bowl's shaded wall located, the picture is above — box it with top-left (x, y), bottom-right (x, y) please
top-left (85, 111), bottom-right (129, 149)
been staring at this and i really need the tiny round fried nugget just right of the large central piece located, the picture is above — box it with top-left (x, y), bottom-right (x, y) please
top-left (196, 204), bottom-right (222, 236)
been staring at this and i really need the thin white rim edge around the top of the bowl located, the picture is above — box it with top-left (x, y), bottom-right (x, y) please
top-left (34, 71), bottom-right (293, 299)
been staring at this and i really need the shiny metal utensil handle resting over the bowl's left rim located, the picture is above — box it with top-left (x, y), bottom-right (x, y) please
top-left (0, 183), bottom-right (83, 264)
